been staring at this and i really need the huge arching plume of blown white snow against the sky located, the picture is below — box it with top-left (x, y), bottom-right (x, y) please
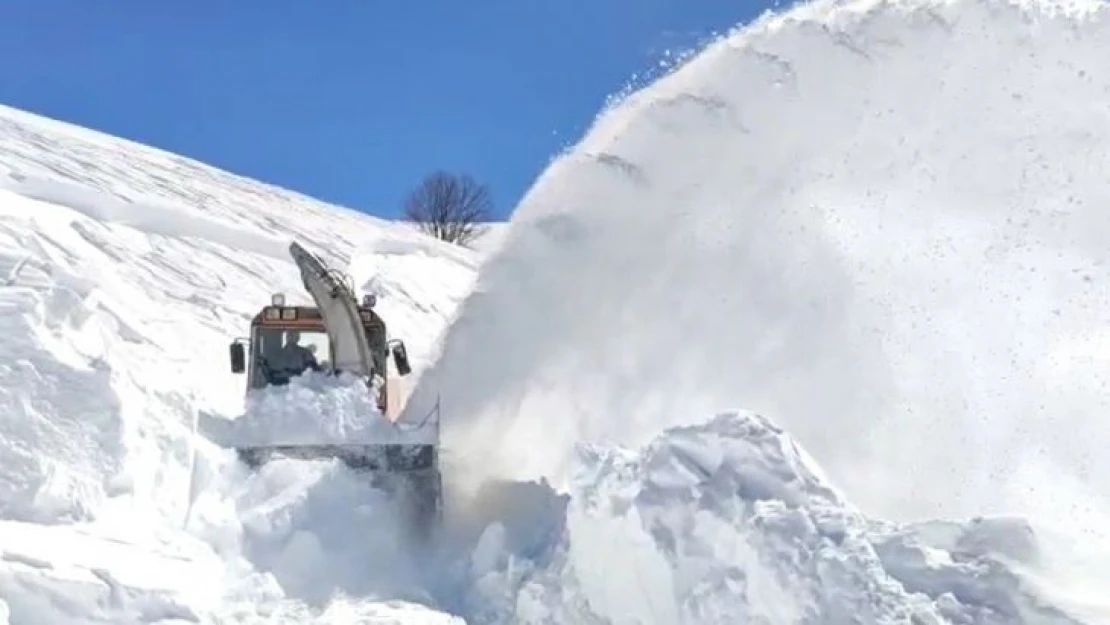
top-left (413, 0), bottom-right (1110, 533)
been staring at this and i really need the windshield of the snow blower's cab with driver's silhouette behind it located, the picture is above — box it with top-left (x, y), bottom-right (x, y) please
top-left (251, 327), bottom-right (332, 389)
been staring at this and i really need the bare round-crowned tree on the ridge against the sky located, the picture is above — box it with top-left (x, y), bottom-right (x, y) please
top-left (404, 171), bottom-right (493, 245)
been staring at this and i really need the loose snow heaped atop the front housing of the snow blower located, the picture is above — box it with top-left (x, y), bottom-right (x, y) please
top-left (201, 371), bottom-right (437, 447)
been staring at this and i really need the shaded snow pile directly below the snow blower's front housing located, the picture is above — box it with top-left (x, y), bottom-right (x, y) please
top-left (188, 460), bottom-right (427, 609)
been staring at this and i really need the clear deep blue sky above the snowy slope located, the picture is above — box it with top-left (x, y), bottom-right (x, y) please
top-left (0, 0), bottom-right (765, 218)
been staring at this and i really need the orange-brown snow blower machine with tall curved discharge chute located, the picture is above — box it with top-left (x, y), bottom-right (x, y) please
top-left (230, 242), bottom-right (443, 536)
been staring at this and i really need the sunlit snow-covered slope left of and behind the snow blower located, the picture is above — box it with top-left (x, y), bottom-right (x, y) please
top-left (0, 102), bottom-right (478, 623)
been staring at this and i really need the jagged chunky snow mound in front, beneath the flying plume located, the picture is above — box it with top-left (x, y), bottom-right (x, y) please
top-left (457, 413), bottom-right (1079, 625)
